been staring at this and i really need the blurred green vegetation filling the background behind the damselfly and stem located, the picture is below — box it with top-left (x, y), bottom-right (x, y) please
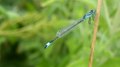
top-left (0, 0), bottom-right (120, 67)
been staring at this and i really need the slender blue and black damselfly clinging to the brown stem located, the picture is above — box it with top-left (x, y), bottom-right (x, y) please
top-left (45, 10), bottom-right (96, 48)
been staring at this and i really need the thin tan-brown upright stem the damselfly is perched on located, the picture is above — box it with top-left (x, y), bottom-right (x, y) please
top-left (88, 0), bottom-right (102, 67)
